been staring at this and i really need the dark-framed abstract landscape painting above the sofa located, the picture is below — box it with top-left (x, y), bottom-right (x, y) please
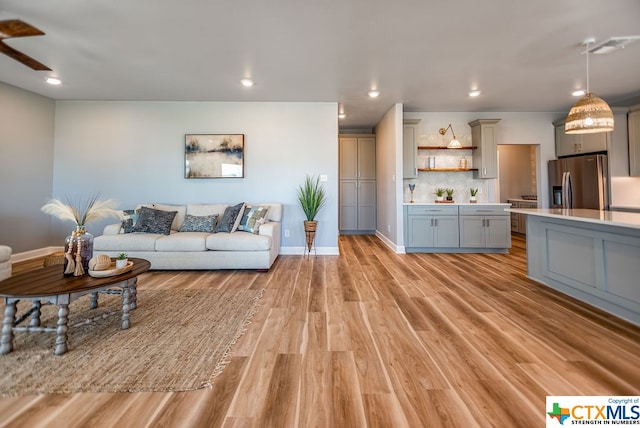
top-left (184, 134), bottom-right (244, 178)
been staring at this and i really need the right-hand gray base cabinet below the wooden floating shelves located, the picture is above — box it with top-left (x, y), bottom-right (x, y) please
top-left (460, 206), bottom-right (511, 248)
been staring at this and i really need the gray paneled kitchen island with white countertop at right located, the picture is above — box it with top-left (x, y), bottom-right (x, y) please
top-left (509, 208), bottom-right (640, 325)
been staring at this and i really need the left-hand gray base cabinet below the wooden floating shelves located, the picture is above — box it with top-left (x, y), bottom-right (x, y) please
top-left (406, 206), bottom-right (460, 248)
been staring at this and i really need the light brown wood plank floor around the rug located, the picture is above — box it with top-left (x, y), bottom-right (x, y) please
top-left (0, 236), bottom-right (640, 427)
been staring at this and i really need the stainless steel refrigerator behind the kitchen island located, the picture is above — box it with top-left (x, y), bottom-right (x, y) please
top-left (549, 155), bottom-right (609, 210)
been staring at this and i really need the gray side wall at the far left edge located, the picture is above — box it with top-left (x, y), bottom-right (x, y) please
top-left (0, 83), bottom-right (55, 253)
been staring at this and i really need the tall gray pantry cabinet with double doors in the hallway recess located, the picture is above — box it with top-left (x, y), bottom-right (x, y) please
top-left (339, 134), bottom-right (376, 234)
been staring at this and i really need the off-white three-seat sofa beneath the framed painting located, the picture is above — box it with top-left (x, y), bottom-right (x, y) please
top-left (93, 203), bottom-right (282, 270)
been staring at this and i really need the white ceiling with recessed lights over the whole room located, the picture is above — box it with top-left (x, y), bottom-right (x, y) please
top-left (0, 0), bottom-right (640, 128)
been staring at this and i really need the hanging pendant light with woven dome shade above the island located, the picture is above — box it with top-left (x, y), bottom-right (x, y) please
top-left (564, 39), bottom-right (613, 134)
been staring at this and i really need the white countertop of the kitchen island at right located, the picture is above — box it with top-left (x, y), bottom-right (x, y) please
top-left (507, 208), bottom-right (640, 229)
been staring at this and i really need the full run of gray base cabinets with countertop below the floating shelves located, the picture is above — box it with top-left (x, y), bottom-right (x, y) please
top-left (403, 202), bottom-right (511, 253)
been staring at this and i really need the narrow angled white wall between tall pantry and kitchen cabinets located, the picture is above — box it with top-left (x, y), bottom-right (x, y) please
top-left (376, 104), bottom-right (403, 249)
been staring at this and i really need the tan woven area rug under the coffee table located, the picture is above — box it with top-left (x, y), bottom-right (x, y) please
top-left (0, 290), bottom-right (262, 396)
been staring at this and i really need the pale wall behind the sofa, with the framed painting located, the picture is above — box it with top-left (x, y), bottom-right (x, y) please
top-left (53, 101), bottom-right (338, 254)
